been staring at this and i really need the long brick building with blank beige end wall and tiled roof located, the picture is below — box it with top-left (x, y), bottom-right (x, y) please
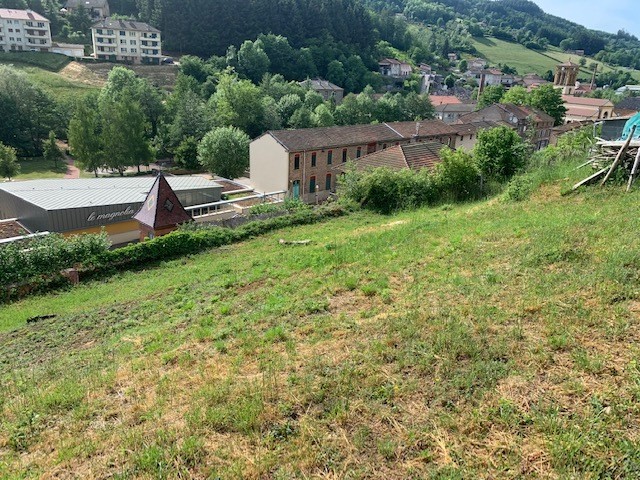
top-left (249, 120), bottom-right (456, 202)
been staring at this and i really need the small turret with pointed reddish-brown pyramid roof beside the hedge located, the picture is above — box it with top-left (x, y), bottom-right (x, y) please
top-left (133, 173), bottom-right (193, 241)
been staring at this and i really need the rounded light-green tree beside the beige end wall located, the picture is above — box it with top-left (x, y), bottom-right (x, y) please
top-left (198, 127), bottom-right (250, 178)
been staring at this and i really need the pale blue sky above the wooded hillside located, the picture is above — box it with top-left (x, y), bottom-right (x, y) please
top-left (533, 0), bottom-right (640, 38)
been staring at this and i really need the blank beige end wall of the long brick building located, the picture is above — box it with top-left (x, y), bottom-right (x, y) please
top-left (249, 134), bottom-right (289, 193)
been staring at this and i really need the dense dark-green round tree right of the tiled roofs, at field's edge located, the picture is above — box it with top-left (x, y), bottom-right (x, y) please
top-left (473, 127), bottom-right (529, 180)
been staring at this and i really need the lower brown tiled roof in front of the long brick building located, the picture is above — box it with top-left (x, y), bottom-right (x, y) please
top-left (334, 142), bottom-right (450, 172)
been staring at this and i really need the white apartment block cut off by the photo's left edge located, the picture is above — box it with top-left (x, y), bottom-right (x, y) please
top-left (0, 8), bottom-right (51, 52)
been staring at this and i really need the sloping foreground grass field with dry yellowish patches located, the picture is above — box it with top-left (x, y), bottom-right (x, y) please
top-left (0, 162), bottom-right (640, 479)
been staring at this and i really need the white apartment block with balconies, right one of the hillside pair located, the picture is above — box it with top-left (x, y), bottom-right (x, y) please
top-left (91, 18), bottom-right (162, 65)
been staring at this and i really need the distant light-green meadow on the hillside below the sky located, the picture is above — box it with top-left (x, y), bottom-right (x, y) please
top-left (473, 37), bottom-right (640, 81)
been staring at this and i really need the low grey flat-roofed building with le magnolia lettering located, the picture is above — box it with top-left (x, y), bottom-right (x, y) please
top-left (0, 176), bottom-right (222, 245)
